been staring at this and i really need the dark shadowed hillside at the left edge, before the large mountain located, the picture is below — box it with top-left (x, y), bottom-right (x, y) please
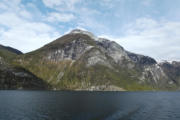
top-left (0, 45), bottom-right (49, 89)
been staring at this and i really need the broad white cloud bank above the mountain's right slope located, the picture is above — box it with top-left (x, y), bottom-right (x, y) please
top-left (103, 18), bottom-right (180, 60)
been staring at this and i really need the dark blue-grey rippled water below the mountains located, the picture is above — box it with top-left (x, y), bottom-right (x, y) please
top-left (0, 91), bottom-right (180, 120)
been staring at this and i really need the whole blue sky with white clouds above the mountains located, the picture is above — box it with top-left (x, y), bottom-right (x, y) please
top-left (0, 0), bottom-right (180, 61)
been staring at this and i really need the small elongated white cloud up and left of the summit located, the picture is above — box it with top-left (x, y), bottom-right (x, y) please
top-left (47, 12), bottom-right (75, 22)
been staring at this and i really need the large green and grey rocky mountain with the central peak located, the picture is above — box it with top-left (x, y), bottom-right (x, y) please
top-left (0, 29), bottom-right (180, 91)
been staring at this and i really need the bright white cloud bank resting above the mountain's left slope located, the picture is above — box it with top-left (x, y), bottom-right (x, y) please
top-left (0, 23), bottom-right (60, 52)
